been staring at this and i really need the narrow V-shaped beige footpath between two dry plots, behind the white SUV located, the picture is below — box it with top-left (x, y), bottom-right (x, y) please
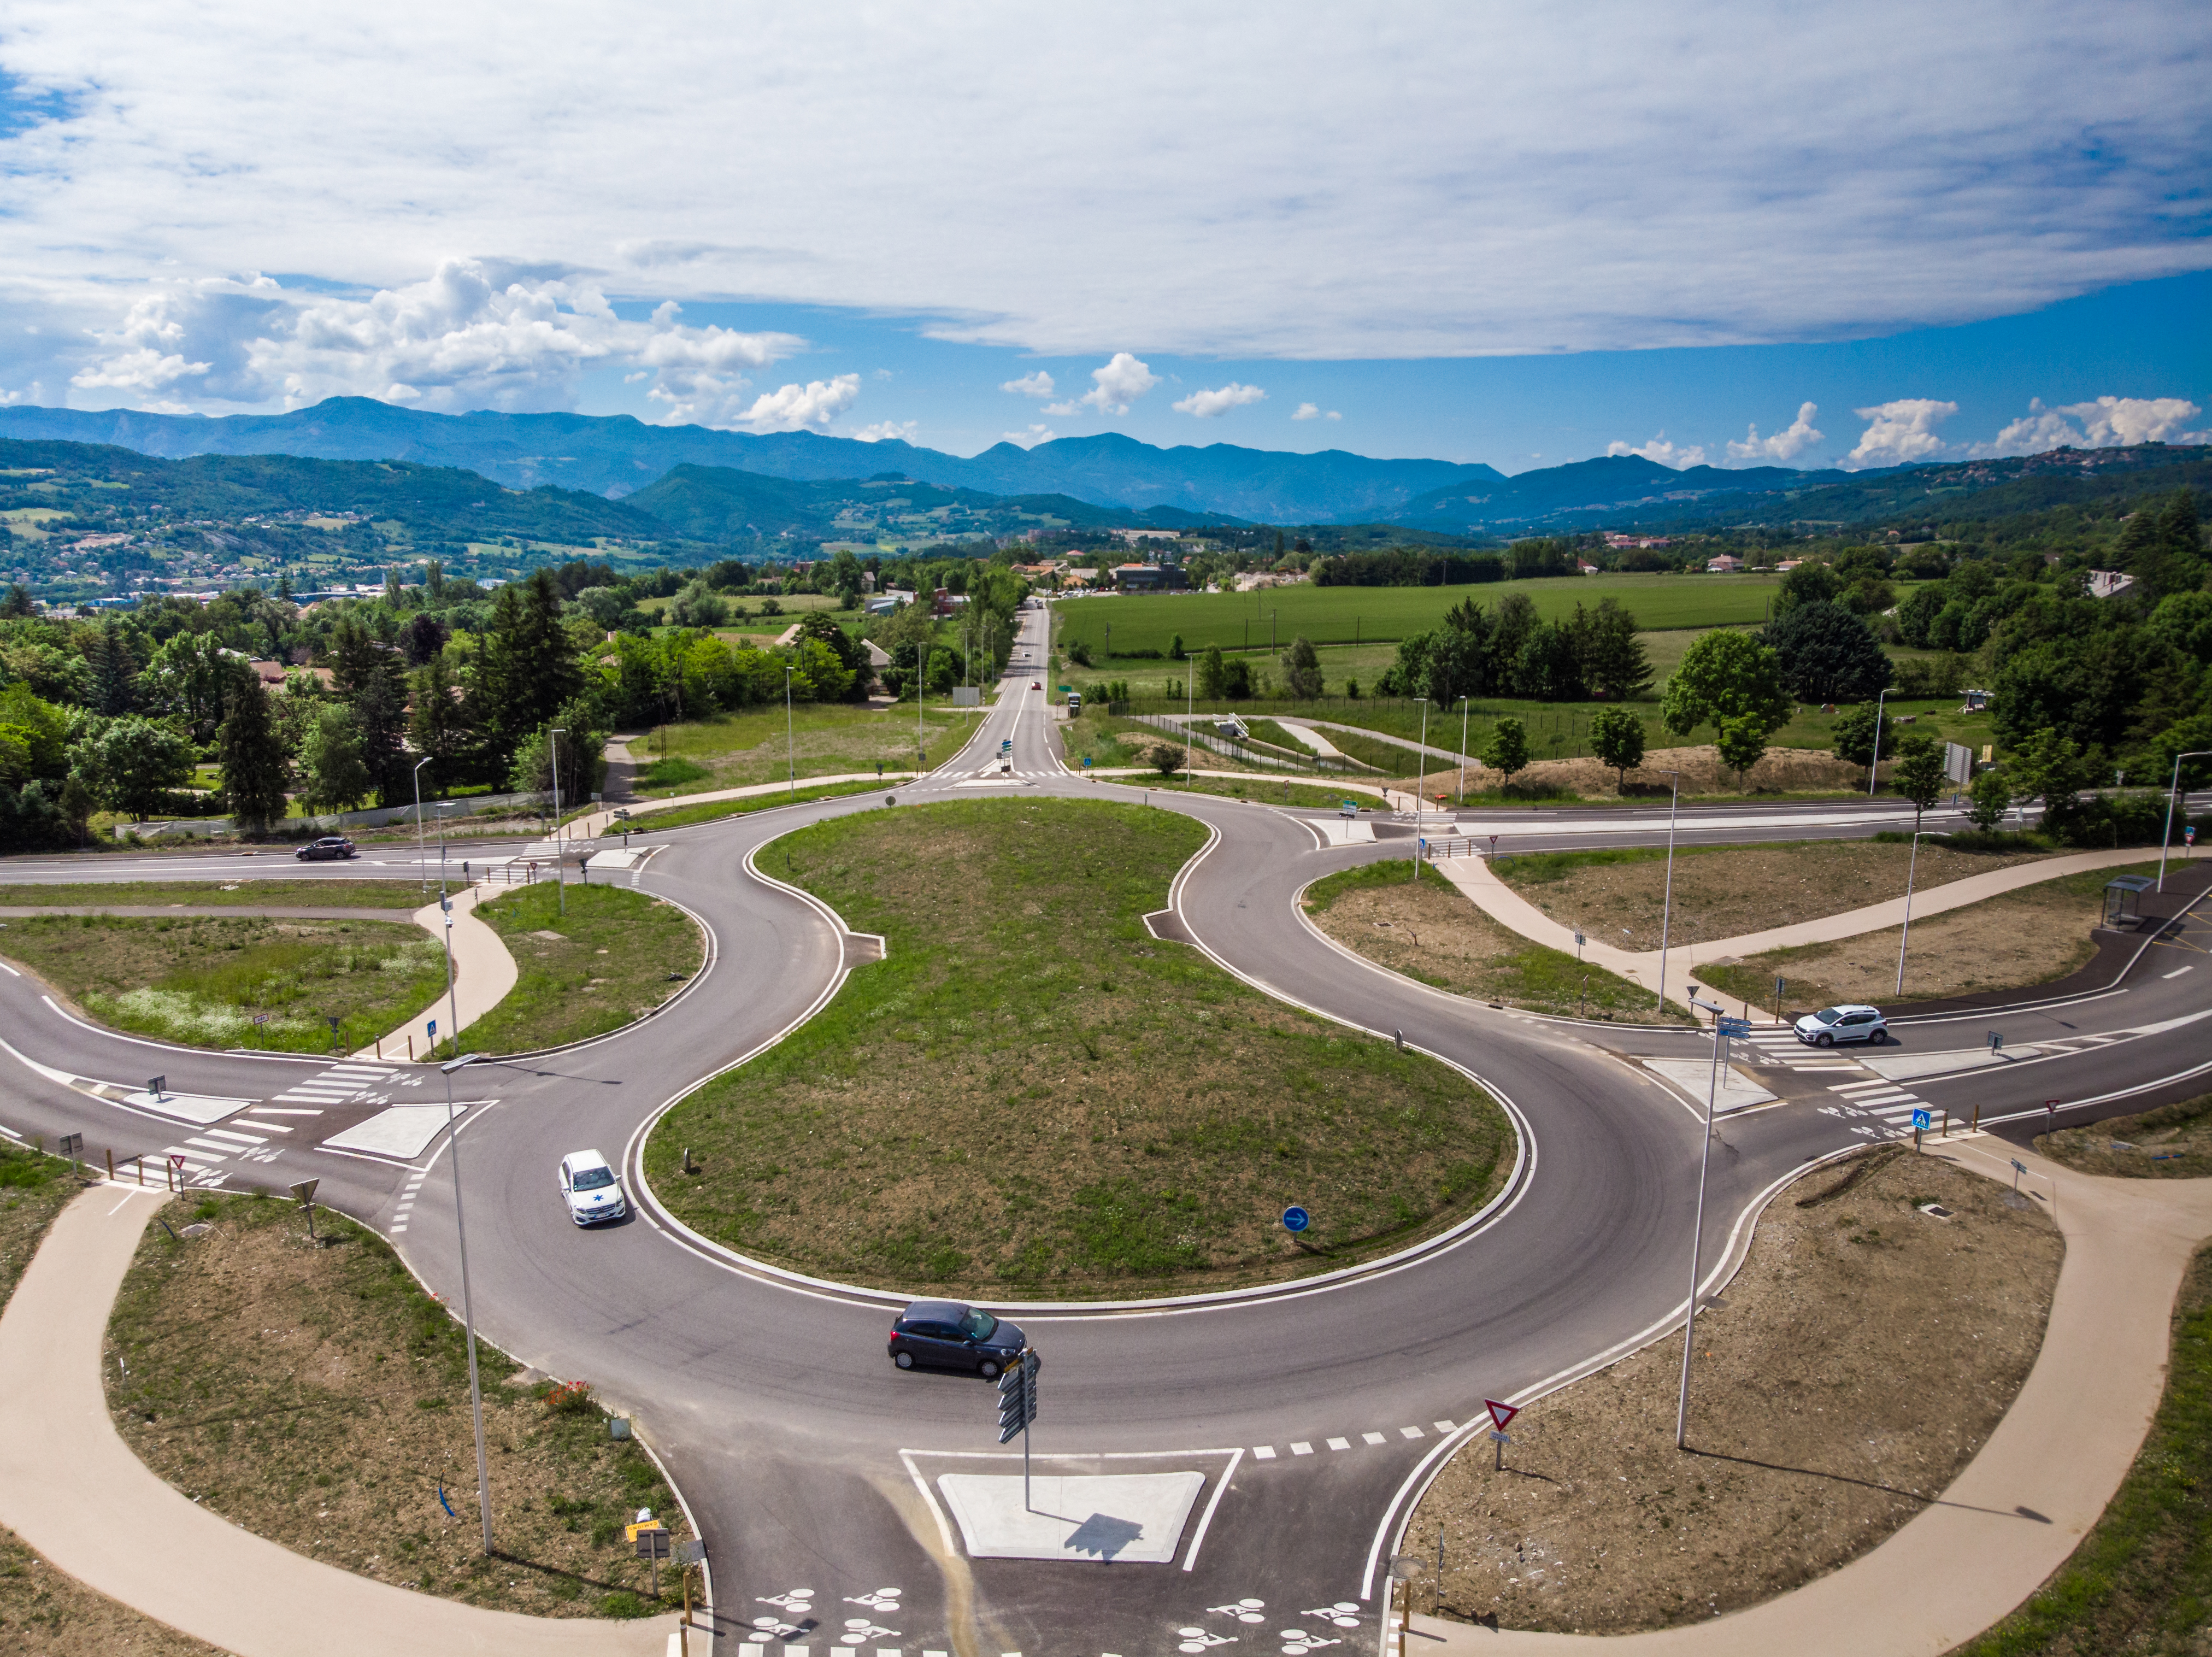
top-left (1429, 845), bottom-right (2157, 1007)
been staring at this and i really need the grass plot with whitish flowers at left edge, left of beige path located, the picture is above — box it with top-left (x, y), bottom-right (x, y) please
top-left (0, 916), bottom-right (445, 1053)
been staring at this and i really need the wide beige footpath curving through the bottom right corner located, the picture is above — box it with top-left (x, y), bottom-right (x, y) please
top-left (1389, 1139), bottom-right (2212, 1657)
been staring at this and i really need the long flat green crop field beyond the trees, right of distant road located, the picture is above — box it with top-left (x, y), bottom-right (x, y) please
top-left (1053, 575), bottom-right (1781, 659)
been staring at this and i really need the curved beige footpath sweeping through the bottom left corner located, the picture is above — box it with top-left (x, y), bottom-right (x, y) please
top-left (0, 1186), bottom-right (677, 1657)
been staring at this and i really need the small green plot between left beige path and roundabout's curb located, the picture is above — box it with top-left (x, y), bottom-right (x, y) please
top-left (457, 880), bottom-right (705, 1053)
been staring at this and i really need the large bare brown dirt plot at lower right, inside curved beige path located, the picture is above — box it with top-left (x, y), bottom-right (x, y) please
top-left (1407, 1148), bottom-right (2064, 1635)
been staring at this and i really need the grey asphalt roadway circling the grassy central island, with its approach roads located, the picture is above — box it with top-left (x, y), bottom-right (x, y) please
top-left (0, 615), bottom-right (2212, 1657)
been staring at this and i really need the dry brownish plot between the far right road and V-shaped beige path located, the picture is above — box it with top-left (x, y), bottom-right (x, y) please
top-left (1493, 841), bottom-right (2061, 942)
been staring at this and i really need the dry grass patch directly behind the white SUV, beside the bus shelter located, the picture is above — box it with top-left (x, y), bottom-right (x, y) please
top-left (1697, 869), bottom-right (2115, 1011)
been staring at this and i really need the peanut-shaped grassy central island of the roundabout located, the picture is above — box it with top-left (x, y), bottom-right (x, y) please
top-left (646, 798), bottom-right (1513, 1298)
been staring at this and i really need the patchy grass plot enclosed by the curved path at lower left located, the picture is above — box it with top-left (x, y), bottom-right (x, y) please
top-left (104, 1197), bottom-right (681, 1617)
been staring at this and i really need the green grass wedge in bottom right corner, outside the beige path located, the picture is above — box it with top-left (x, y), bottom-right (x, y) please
top-left (1953, 1248), bottom-right (2212, 1657)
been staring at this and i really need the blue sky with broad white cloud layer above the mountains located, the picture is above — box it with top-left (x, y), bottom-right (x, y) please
top-left (0, 0), bottom-right (2212, 471)
